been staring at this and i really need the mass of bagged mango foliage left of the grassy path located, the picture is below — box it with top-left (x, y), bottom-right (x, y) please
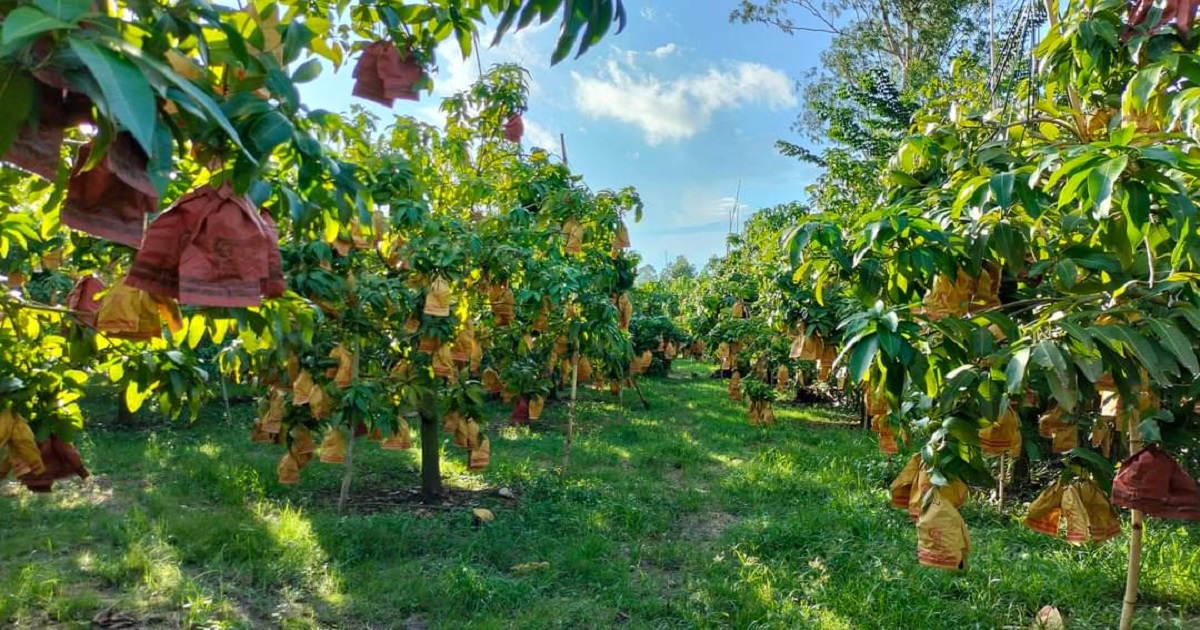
top-left (0, 0), bottom-right (641, 493)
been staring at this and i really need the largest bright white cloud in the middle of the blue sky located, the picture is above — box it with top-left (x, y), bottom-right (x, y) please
top-left (571, 55), bottom-right (797, 146)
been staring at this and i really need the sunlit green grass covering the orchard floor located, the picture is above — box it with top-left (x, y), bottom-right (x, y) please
top-left (0, 361), bottom-right (1200, 629)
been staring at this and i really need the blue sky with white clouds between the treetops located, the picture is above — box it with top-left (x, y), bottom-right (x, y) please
top-left (304, 0), bottom-right (828, 268)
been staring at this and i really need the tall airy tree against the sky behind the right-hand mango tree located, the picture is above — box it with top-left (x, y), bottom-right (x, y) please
top-left (730, 0), bottom-right (1004, 220)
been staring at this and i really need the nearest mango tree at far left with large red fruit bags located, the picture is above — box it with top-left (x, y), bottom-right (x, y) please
top-left (0, 0), bottom-right (625, 496)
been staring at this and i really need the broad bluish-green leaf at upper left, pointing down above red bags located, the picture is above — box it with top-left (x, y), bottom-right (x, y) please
top-left (68, 37), bottom-right (158, 156)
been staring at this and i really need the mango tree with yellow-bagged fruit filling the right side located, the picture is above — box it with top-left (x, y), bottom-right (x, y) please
top-left (793, 1), bottom-right (1200, 628)
